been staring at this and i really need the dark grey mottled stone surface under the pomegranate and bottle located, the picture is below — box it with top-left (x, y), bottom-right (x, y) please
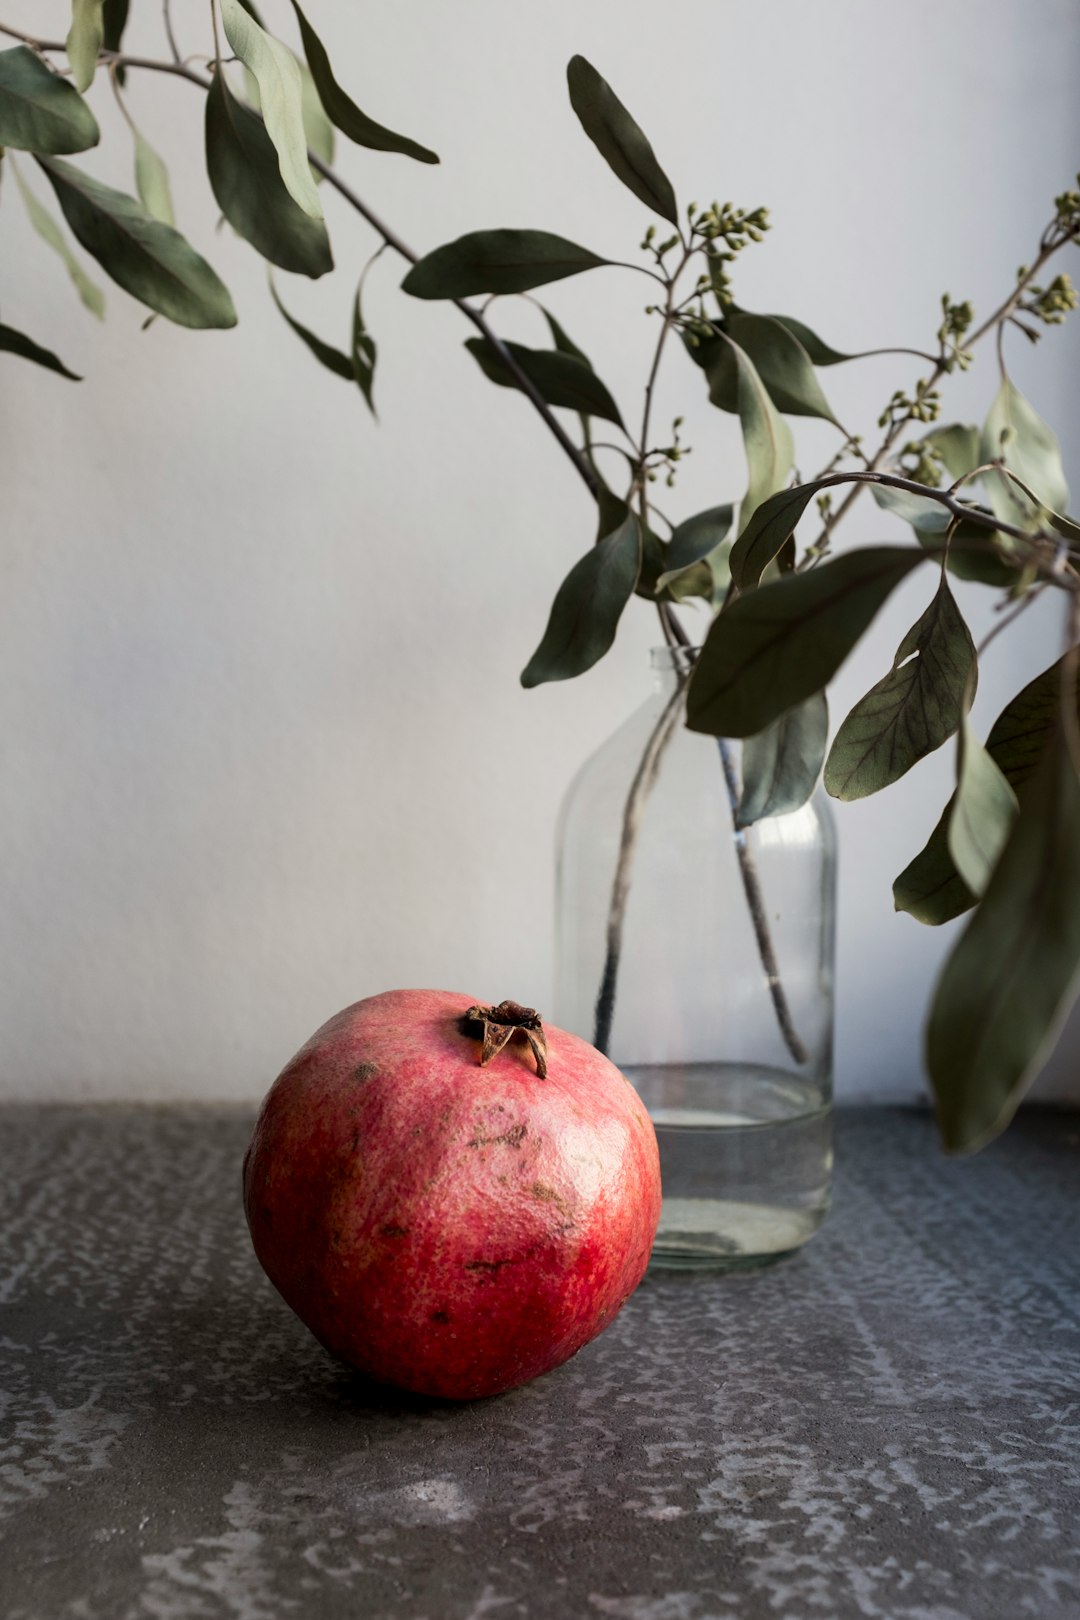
top-left (0, 1108), bottom-right (1080, 1620)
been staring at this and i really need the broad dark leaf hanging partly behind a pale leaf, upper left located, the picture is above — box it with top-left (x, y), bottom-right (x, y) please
top-left (206, 73), bottom-right (334, 277)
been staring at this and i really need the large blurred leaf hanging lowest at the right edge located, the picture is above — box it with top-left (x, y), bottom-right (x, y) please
top-left (926, 732), bottom-right (1080, 1152)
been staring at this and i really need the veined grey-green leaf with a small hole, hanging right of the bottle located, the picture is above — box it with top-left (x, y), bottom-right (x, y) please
top-left (824, 575), bottom-right (978, 799)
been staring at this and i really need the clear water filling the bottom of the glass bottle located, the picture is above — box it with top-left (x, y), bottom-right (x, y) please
top-left (623, 1063), bottom-right (832, 1270)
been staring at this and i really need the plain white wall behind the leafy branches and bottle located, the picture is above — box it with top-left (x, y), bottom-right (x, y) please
top-left (0, 0), bottom-right (1080, 1098)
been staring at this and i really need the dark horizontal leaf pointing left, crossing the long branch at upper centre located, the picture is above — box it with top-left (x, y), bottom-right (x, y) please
top-left (402, 230), bottom-right (607, 298)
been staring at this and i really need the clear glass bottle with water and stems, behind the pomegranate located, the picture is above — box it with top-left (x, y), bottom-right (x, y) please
top-left (554, 648), bottom-right (836, 1270)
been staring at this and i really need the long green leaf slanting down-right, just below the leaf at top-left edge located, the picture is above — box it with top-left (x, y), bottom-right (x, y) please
top-left (37, 157), bottom-right (236, 327)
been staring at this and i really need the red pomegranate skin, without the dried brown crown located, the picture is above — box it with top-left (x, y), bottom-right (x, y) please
top-left (243, 990), bottom-right (661, 1400)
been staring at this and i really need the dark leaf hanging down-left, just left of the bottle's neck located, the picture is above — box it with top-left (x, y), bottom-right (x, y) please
top-left (521, 514), bottom-right (641, 687)
